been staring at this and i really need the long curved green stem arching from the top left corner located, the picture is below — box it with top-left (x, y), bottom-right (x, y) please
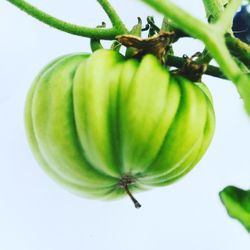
top-left (7, 0), bottom-right (125, 40)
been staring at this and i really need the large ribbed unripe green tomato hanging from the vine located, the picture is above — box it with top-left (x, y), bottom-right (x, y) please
top-left (25, 50), bottom-right (215, 207)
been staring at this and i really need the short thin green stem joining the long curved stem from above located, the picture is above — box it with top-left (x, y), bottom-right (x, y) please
top-left (97, 0), bottom-right (128, 34)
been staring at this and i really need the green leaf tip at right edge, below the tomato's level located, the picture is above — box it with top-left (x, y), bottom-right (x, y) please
top-left (220, 186), bottom-right (250, 233)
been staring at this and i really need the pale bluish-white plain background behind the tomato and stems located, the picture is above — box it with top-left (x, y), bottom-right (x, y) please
top-left (0, 0), bottom-right (250, 250)
